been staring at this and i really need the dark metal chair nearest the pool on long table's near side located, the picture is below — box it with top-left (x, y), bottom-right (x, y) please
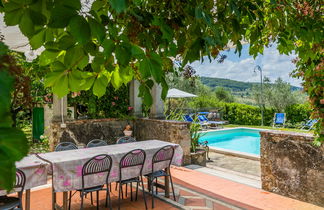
top-left (145, 145), bottom-right (176, 208)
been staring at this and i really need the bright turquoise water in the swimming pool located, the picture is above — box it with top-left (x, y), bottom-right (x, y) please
top-left (199, 128), bottom-right (260, 155)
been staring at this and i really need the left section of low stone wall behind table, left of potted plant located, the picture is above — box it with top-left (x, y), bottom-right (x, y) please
top-left (50, 119), bottom-right (134, 150)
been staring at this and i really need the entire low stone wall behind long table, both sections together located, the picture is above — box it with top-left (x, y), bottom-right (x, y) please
top-left (49, 118), bottom-right (190, 164)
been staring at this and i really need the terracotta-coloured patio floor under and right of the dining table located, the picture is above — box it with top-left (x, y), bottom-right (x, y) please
top-left (18, 167), bottom-right (324, 210)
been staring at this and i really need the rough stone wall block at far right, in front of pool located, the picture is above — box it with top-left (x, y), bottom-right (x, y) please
top-left (261, 131), bottom-right (324, 206)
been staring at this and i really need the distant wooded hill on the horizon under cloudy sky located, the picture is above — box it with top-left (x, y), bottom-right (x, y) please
top-left (200, 77), bottom-right (302, 92)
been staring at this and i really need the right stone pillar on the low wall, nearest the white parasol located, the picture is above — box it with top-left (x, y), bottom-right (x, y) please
top-left (150, 84), bottom-right (165, 119)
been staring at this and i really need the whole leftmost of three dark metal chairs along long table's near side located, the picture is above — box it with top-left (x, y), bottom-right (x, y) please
top-left (69, 154), bottom-right (112, 209)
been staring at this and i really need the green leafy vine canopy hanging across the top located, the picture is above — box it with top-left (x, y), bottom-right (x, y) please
top-left (0, 0), bottom-right (324, 189)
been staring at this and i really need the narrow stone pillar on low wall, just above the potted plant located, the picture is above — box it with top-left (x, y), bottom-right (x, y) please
top-left (129, 80), bottom-right (142, 117)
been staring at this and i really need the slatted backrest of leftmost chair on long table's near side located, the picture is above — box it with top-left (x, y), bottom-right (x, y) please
top-left (82, 154), bottom-right (112, 188)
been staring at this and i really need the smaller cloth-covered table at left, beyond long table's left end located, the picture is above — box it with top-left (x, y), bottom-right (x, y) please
top-left (0, 155), bottom-right (49, 210)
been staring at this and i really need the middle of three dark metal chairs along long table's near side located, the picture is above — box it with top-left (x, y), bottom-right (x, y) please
top-left (118, 149), bottom-right (147, 209)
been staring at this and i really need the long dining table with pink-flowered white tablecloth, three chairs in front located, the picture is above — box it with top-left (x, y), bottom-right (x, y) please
top-left (38, 140), bottom-right (183, 209)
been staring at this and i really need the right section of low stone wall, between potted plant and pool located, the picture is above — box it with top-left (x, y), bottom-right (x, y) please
top-left (135, 119), bottom-right (190, 164)
